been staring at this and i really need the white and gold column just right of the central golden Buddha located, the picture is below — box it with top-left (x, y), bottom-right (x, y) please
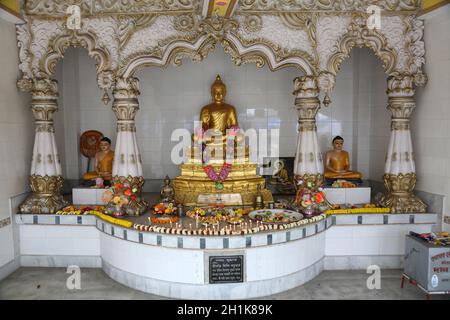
top-left (294, 76), bottom-right (323, 187)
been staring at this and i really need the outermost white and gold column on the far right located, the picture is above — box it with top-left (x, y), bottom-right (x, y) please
top-left (380, 74), bottom-right (427, 213)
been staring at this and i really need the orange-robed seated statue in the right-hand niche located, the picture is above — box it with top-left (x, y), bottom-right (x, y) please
top-left (324, 136), bottom-right (362, 179)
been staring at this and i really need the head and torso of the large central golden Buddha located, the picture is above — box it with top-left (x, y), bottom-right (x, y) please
top-left (200, 75), bottom-right (238, 141)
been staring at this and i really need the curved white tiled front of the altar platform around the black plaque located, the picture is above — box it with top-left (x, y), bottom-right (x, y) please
top-left (15, 214), bottom-right (437, 299)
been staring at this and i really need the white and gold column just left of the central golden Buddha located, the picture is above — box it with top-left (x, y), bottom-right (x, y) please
top-left (112, 78), bottom-right (147, 215)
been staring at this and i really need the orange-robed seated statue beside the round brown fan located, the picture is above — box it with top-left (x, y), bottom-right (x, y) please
top-left (83, 137), bottom-right (114, 181)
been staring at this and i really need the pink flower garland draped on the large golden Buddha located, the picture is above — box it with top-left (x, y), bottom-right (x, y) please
top-left (196, 126), bottom-right (240, 190)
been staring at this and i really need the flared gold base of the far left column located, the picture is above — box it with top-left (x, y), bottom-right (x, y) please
top-left (19, 175), bottom-right (68, 214)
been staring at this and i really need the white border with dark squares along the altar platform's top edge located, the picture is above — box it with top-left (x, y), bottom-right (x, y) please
top-left (14, 214), bottom-right (437, 249)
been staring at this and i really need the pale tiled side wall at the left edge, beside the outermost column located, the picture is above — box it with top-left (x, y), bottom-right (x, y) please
top-left (0, 18), bottom-right (34, 276)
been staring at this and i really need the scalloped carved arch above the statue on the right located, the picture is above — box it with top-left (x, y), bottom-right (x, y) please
top-left (327, 15), bottom-right (397, 75)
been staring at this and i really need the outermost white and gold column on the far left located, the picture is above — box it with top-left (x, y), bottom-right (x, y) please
top-left (19, 79), bottom-right (67, 214)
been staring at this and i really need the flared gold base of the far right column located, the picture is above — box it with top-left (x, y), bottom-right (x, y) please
top-left (379, 172), bottom-right (427, 213)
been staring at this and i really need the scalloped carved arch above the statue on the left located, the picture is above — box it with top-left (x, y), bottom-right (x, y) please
top-left (37, 31), bottom-right (113, 89)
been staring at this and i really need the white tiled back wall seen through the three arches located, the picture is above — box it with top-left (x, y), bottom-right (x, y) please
top-left (58, 48), bottom-right (390, 179)
